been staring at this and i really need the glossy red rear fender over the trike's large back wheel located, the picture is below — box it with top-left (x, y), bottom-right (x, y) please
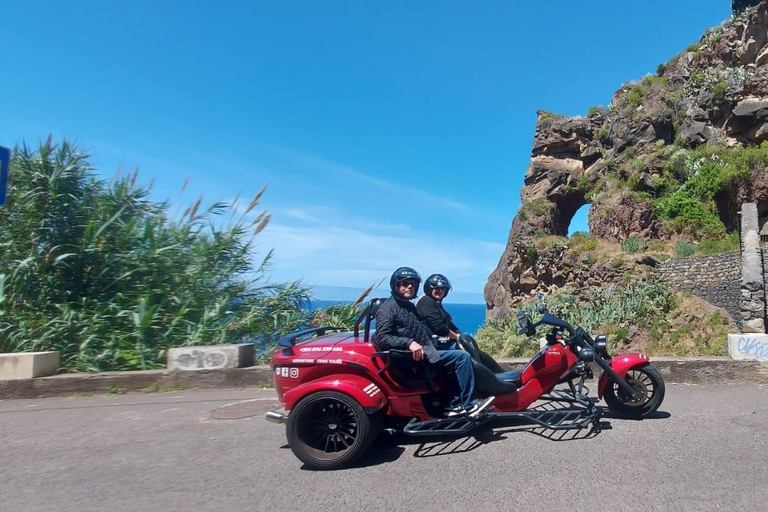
top-left (284, 375), bottom-right (387, 414)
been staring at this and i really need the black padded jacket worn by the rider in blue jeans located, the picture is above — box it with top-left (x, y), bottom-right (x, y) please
top-left (373, 296), bottom-right (432, 350)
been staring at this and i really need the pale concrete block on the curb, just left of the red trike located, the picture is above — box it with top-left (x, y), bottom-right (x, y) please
top-left (167, 343), bottom-right (254, 371)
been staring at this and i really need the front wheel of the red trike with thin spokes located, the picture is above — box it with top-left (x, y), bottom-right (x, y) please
top-left (605, 364), bottom-right (665, 419)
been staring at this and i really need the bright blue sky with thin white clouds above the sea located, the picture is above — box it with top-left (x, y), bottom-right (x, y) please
top-left (0, 0), bottom-right (730, 301)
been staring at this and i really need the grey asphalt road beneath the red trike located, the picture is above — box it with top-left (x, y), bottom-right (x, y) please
top-left (0, 385), bottom-right (768, 512)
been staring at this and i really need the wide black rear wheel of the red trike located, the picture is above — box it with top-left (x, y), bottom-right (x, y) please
top-left (286, 391), bottom-right (381, 470)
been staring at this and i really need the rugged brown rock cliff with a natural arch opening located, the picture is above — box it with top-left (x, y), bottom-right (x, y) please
top-left (485, 0), bottom-right (768, 318)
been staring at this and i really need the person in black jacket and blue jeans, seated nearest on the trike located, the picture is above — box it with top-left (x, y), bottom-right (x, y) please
top-left (374, 267), bottom-right (494, 417)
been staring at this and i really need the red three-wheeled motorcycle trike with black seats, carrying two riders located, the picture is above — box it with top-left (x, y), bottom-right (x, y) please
top-left (267, 299), bottom-right (664, 469)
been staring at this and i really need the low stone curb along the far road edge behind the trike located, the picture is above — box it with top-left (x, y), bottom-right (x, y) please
top-left (0, 357), bottom-right (768, 399)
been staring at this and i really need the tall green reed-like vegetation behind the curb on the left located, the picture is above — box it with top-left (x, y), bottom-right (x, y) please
top-left (0, 139), bottom-right (308, 371)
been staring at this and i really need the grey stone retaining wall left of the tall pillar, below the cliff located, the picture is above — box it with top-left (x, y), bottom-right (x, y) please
top-left (658, 251), bottom-right (742, 327)
